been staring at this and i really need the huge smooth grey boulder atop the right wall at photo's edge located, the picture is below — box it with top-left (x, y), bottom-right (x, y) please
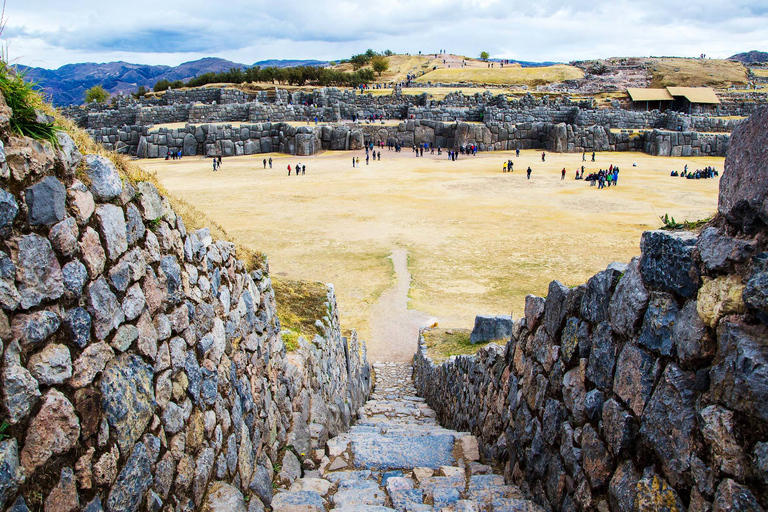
top-left (717, 106), bottom-right (768, 231)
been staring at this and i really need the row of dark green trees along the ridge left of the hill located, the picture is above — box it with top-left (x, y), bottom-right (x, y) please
top-left (153, 66), bottom-right (381, 92)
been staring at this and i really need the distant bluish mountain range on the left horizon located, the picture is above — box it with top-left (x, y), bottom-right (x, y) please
top-left (18, 57), bottom-right (328, 106)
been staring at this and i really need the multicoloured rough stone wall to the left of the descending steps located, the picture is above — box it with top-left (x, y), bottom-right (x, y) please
top-left (0, 90), bottom-right (370, 511)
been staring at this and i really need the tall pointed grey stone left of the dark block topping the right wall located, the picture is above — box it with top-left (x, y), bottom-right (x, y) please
top-left (608, 258), bottom-right (648, 339)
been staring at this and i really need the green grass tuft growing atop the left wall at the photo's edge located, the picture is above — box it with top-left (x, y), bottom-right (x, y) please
top-left (0, 62), bottom-right (60, 147)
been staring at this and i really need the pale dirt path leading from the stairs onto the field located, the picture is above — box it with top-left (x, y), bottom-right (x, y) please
top-left (368, 249), bottom-right (435, 362)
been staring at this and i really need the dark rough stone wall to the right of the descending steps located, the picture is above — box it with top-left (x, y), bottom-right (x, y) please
top-left (414, 107), bottom-right (768, 511)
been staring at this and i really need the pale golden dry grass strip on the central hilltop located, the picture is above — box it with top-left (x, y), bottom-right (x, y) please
top-left (416, 64), bottom-right (584, 87)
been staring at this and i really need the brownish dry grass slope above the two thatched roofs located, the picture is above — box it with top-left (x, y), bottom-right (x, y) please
top-left (649, 58), bottom-right (747, 89)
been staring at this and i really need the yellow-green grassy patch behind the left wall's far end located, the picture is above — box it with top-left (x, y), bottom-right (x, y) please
top-left (272, 279), bottom-right (329, 352)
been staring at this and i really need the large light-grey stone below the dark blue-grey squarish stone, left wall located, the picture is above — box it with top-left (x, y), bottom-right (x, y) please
top-left (12, 233), bottom-right (64, 309)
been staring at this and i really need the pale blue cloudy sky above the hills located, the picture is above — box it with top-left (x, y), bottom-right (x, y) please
top-left (2, 0), bottom-right (768, 68)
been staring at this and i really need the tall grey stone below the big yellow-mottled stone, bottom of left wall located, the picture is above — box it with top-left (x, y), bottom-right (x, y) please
top-left (107, 443), bottom-right (154, 511)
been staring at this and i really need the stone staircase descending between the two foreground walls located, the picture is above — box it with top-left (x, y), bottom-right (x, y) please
top-left (272, 363), bottom-right (542, 512)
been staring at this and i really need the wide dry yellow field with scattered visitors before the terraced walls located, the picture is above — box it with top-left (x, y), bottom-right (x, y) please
top-left (139, 150), bottom-right (723, 360)
